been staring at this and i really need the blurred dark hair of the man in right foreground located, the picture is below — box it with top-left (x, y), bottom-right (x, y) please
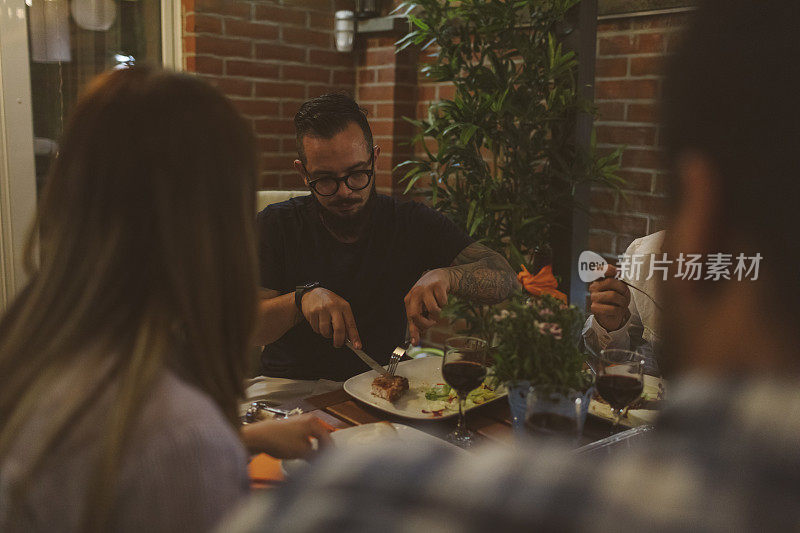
top-left (662, 0), bottom-right (800, 313)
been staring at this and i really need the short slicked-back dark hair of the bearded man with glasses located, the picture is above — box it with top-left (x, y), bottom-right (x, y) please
top-left (294, 93), bottom-right (372, 164)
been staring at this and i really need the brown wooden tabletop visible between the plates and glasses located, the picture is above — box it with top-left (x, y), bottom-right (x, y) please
top-left (281, 389), bottom-right (626, 445)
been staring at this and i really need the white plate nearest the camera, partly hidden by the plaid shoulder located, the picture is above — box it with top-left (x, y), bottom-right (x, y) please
top-left (281, 422), bottom-right (466, 477)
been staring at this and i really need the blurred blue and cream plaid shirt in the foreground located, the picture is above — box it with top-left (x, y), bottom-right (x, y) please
top-left (224, 379), bottom-right (800, 533)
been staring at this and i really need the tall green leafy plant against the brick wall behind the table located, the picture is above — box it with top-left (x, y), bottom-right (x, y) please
top-left (398, 0), bottom-right (620, 333)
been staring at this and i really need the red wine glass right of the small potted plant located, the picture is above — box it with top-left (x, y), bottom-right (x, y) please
top-left (595, 349), bottom-right (645, 430)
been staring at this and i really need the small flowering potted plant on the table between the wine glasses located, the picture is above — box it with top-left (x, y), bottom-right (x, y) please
top-left (488, 266), bottom-right (593, 433)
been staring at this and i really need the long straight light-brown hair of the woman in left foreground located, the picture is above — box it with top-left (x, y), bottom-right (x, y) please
top-left (0, 67), bottom-right (257, 530)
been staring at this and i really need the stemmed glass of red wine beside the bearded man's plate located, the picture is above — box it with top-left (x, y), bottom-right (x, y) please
top-left (442, 337), bottom-right (487, 448)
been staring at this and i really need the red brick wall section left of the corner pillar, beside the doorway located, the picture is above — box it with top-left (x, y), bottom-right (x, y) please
top-left (183, 0), bottom-right (357, 189)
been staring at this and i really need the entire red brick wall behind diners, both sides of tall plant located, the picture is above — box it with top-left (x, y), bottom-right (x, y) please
top-left (178, 0), bottom-right (691, 255)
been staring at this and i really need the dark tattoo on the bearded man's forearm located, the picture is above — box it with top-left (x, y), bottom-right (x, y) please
top-left (445, 243), bottom-right (520, 304)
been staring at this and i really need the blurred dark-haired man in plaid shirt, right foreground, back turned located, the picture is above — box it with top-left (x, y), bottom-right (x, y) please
top-left (222, 0), bottom-right (800, 533)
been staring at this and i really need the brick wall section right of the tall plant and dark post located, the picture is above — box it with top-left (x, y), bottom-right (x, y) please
top-left (589, 9), bottom-right (691, 255)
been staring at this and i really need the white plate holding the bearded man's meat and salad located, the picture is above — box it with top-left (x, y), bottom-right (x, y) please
top-left (344, 357), bottom-right (508, 420)
